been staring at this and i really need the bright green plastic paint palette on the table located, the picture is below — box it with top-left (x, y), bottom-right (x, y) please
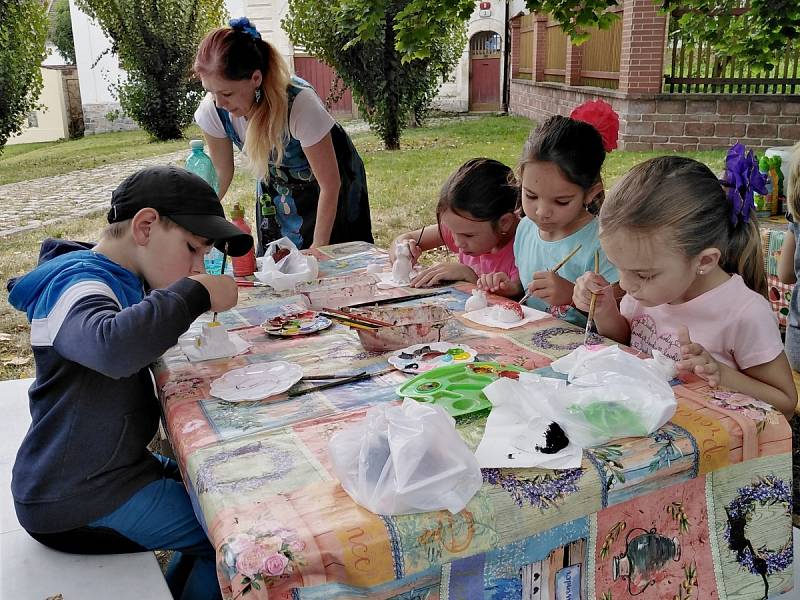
top-left (397, 362), bottom-right (526, 417)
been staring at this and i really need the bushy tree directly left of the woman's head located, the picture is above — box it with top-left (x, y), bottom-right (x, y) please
top-left (75, 0), bottom-right (225, 140)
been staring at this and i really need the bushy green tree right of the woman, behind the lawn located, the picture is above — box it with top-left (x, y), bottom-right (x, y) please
top-left (282, 0), bottom-right (475, 150)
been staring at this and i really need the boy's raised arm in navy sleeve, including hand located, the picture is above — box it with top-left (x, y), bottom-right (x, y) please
top-left (53, 275), bottom-right (233, 379)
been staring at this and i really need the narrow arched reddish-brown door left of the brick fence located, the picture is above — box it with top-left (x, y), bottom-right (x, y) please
top-left (469, 31), bottom-right (501, 111)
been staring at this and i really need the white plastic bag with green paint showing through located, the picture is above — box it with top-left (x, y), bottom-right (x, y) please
top-left (536, 346), bottom-right (677, 448)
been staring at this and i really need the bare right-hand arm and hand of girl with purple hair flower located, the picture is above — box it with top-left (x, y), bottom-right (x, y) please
top-left (675, 327), bottom-right (797, 420)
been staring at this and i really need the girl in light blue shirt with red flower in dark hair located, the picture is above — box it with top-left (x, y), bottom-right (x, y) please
top-left (477, 100), bottom-right (619, 327)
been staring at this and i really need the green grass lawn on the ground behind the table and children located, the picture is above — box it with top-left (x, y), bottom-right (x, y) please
top-left (0, 117), bottom-right (725, 379)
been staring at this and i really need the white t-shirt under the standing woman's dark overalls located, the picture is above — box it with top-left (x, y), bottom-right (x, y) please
top-left (194, 88), bottom-right (336, 148)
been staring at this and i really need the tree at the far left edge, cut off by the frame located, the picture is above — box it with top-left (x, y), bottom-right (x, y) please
top-left (0, 0), bottom-right (47, 153)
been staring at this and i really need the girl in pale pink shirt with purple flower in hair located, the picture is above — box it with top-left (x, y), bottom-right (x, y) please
top-left (573, 151), bottom-right (797, 419)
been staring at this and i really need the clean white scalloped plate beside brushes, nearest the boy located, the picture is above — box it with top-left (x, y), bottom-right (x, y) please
top-left (210, 360), bottom-right (303, 402)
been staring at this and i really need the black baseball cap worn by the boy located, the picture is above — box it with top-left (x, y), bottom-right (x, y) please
top-left (107, 165), bottom-right (253, 256)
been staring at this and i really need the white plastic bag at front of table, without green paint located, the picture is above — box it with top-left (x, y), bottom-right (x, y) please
top-left (328, 398), bottom-right (483, 515)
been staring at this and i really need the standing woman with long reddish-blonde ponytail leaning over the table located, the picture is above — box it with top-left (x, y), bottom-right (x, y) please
top-left (194, 17), bottom-right (373, 255)
